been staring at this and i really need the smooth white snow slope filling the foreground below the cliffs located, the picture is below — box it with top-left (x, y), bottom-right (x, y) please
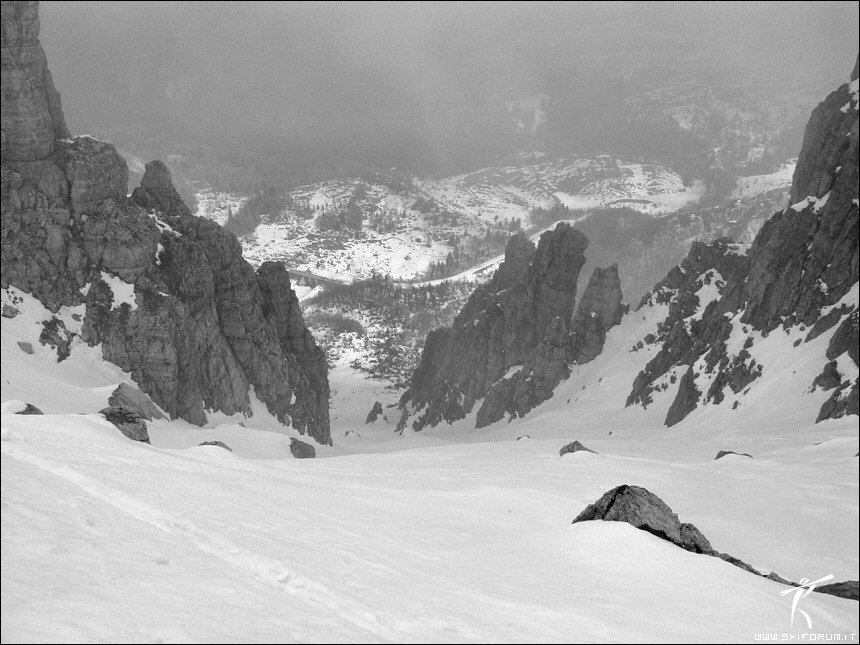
top-left (0, 284), bottom-right (858, 642)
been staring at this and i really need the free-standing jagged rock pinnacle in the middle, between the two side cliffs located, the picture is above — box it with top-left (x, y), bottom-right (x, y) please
top-left (399, 223), bottom-right (622, 430)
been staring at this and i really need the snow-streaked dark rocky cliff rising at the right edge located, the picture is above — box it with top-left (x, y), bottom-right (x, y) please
top-left (627, 57), bottom-right (860, 426)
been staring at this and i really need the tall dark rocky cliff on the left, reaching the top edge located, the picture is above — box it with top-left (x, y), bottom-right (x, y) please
top-left (0, 2), bottom-right (331, 444)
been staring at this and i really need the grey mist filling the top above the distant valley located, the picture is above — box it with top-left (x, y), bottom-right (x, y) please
top-left (41, 2), bottom-right (858, 179)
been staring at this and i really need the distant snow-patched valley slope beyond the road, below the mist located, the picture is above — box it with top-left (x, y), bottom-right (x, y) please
top-left (197, 150), bottom-right (794, 308)
